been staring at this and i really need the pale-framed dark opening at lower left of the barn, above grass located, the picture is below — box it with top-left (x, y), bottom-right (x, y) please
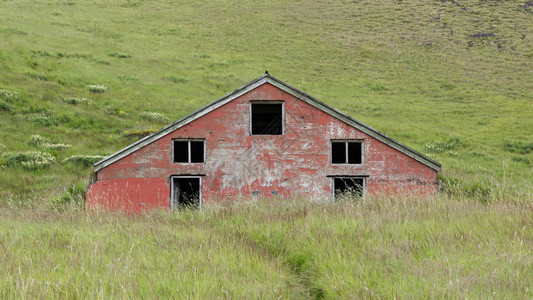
top-left (172, 177), bottom-right (200, 208)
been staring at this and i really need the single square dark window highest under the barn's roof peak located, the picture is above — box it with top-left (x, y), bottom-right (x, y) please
top-left (251, 102), bottom-right (283, 135)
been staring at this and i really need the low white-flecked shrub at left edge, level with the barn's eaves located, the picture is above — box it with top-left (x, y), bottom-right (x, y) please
top-left (0, 151), bottom-right (55, 170)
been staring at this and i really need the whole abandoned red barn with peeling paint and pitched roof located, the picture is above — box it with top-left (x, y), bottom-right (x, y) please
top-left (86, 73), bottom-right (440, 211)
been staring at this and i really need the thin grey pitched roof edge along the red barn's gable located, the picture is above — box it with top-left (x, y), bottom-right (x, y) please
top-left (94, 72), bottom-right (441, 172)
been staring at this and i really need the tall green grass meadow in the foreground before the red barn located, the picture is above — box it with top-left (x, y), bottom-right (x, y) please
top-left (0, 195), bottom-right (533, 299)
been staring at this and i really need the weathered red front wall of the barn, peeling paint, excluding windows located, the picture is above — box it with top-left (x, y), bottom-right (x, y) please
top-left (87, 83), bottom-right (437, 209)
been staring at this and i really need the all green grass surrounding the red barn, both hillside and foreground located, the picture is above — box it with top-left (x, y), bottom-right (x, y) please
top-left (0, 0), bottom-right (533, 299)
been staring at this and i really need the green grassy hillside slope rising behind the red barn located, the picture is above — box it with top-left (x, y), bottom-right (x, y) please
top-left (0, 0), bottom-right (533, 204)
